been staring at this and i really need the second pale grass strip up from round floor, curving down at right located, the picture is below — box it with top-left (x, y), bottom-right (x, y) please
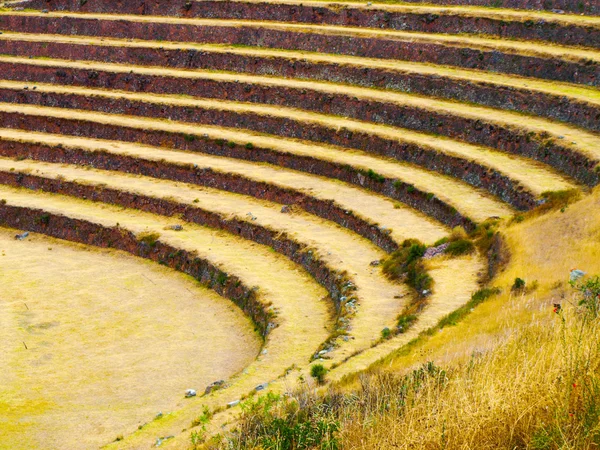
top-left (0, 158), bottom-right (418, 361)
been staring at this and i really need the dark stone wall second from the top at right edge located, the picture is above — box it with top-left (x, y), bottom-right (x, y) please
top-left (16, 0), bottom-right (600, 48)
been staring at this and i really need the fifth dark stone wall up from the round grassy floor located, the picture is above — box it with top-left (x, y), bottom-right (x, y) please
top-left (0, 89), bottom-right (544, 210)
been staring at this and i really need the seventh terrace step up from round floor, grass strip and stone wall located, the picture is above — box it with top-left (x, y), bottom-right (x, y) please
top-left (0, 33), bottom-right (600, 131)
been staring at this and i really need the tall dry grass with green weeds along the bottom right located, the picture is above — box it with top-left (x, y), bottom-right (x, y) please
top-left (213, 290), bottom-right (600, 450)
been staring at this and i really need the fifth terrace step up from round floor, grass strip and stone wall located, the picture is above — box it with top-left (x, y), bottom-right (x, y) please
top-left (0, 80), bottom-right (584, 209)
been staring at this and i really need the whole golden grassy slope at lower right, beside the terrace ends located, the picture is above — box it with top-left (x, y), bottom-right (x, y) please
top-left (216, 189), bottom-right (600, 449)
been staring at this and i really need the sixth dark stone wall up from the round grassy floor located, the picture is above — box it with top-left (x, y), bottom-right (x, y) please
top-left (0, 64), bottom-right (598, 190)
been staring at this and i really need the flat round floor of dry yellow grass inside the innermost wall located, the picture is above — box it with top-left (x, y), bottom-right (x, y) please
top-left (0, 229), bottom-right (261, 449)
